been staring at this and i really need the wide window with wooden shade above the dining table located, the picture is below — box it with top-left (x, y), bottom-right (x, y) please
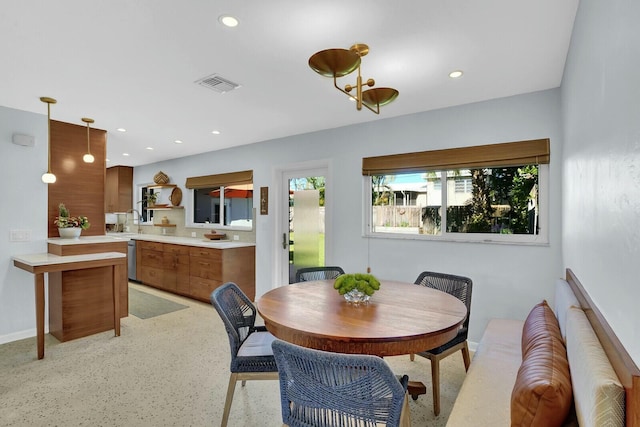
top-left (363, 140), bottom-right (549, 243)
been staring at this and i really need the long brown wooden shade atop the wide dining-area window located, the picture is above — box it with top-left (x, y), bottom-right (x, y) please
top-left (362, 138), bottom-right (549, 175)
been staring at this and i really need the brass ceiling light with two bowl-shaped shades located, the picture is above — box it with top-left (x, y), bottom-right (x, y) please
top-left (309, 44), bottom-right (398, 114)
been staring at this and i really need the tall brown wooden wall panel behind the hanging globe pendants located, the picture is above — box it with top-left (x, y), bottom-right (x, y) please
top-left (48, 117), bottom-right (107, 237)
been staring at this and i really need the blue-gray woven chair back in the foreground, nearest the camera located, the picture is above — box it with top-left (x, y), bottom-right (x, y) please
top-left (272, 339), bottom-right (410, 427)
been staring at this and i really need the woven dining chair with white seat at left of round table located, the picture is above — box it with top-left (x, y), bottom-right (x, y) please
top-left (211, 282), bottom-right (278, 427)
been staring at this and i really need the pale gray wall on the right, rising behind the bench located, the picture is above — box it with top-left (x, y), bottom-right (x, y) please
top-left (562, 0), bottom-right (640, 364)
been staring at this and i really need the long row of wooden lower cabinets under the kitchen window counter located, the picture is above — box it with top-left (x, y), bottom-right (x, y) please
top-left (137, 240), bottom-right (256, 302)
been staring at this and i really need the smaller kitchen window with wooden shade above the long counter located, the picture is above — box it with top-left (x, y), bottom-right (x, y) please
top-left (186, 171), bottom-right (253, 230)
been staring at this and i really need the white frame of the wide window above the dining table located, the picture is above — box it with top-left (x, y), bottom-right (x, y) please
top-left (362, 164), bottom-right (550, 246)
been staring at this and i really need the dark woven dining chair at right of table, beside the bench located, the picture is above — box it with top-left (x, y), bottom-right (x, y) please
top-left (411, 271), bottom-right (473, 415)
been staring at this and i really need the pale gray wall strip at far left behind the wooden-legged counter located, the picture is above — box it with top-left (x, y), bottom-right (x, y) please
top-left (0, 104), bottom-right (48, 342)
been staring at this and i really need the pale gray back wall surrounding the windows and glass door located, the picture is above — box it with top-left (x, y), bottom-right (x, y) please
top-left (134, 89), bottom-right (564, 348)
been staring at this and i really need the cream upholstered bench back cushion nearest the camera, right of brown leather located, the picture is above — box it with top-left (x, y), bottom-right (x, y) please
top-left (567, 308), bottom-right (625, 427)
